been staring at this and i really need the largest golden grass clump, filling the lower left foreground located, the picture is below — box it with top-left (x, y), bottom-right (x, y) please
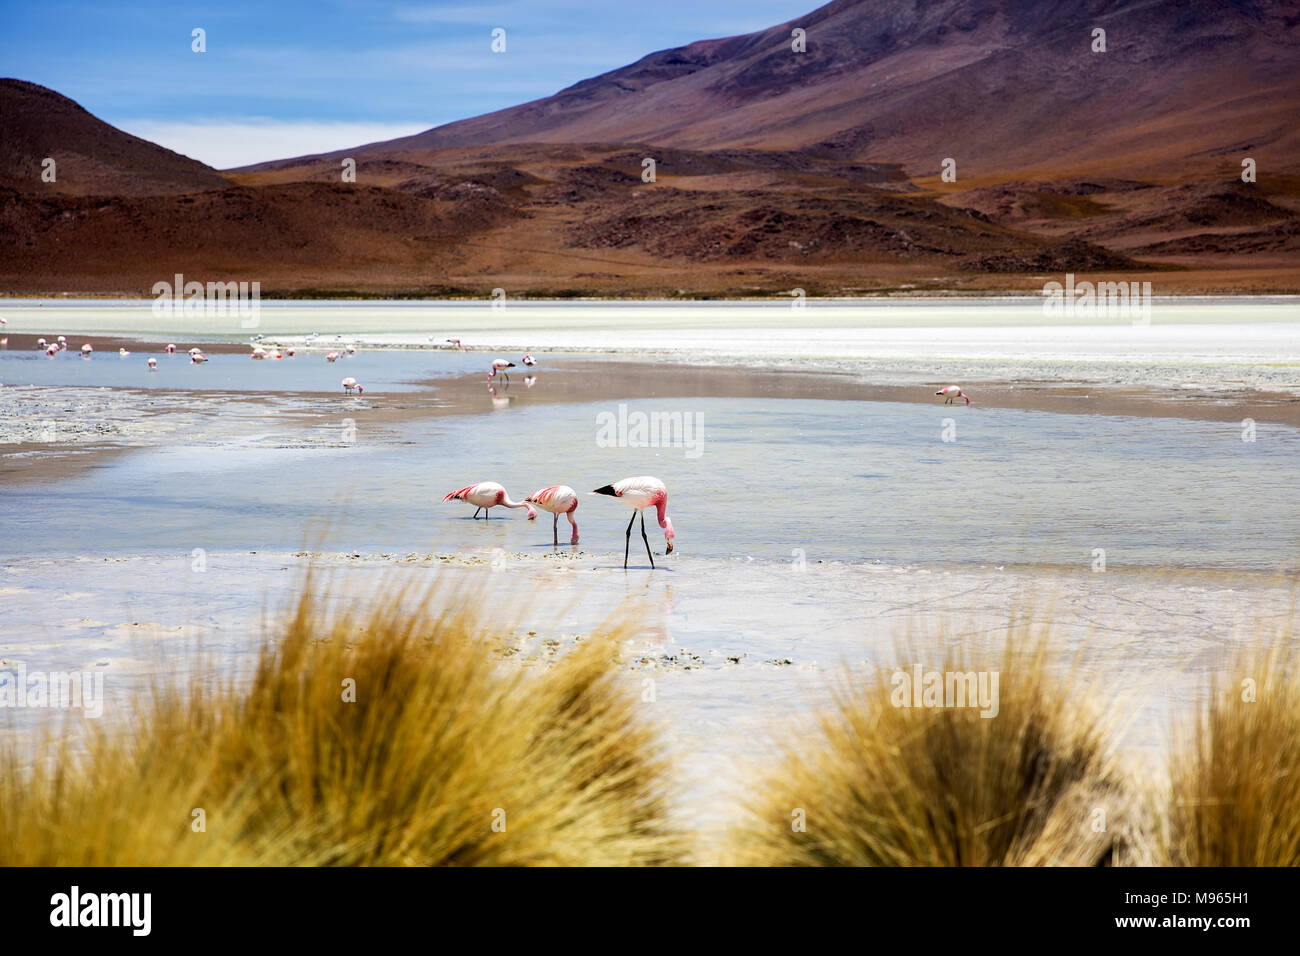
top-left (0, 583), bottom-right (683, 866)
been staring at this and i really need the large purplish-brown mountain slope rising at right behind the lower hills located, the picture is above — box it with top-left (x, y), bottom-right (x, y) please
top-left (252, 0), bottom-right (1300, 177)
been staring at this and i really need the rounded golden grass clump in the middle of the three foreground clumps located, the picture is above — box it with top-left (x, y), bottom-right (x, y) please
top-left (733, 640), bottom-right (1136, 866)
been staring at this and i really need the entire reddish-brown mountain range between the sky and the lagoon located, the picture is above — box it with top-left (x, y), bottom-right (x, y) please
top-left (0, 0), bottom-right (1300, 298)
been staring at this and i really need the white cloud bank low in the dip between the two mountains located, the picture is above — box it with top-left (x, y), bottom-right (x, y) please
top-left (113, 117), bottom-right (430, 169)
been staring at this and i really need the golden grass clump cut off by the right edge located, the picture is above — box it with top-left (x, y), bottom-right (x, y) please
top-left (1166, 640), bottom-right (1300, 866)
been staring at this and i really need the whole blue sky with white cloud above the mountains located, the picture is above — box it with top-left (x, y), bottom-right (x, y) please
top-left (0, 0), bottom-right (820, 168)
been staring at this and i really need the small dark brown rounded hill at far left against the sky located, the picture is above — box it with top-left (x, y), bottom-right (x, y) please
top-left (0, 79), bottom-right (229, 196)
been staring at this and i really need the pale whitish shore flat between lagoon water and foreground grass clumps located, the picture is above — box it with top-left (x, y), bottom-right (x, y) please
top-left (0, 550), bottom-right (1295, 830)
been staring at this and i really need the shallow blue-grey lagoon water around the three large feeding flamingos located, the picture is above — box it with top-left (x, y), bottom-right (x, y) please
top-left (0, 371), bottom-right (1300, 570)
